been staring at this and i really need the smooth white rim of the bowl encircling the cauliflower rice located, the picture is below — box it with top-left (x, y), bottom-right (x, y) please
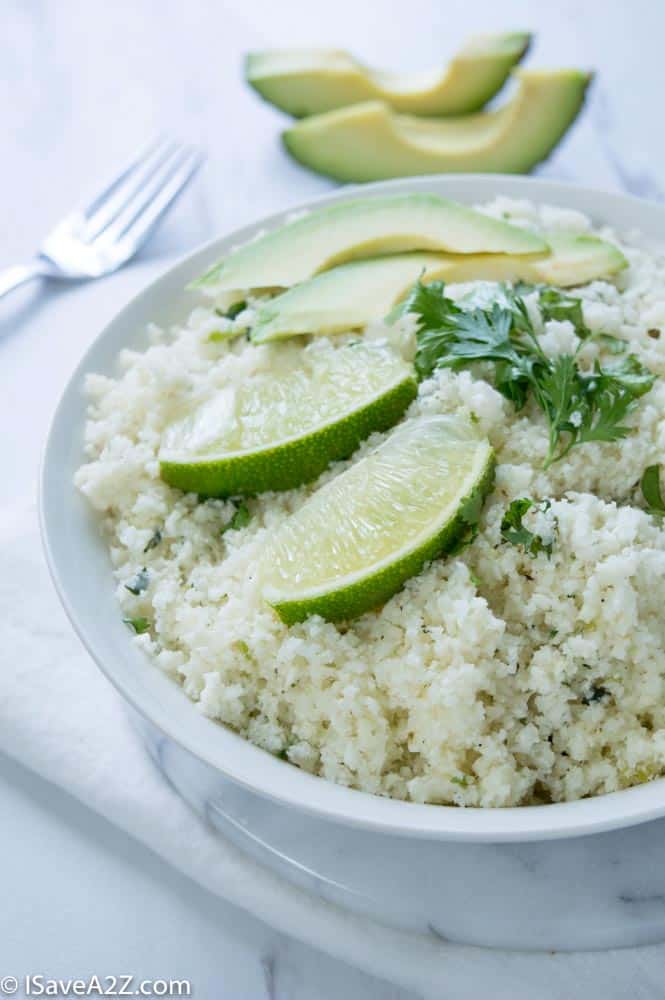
top-left (38, 174), bottom-right (665, 843)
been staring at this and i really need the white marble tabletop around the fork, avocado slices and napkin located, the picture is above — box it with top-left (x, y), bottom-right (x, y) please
top-left (0, 0), bottom-right (665, 1000)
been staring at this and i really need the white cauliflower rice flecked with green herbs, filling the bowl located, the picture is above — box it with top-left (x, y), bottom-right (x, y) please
top-left (76, 199), bottom-right (665, 806)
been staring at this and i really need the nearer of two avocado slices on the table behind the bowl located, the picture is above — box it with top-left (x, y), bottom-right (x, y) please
top-left (282, 70), bottom-right (591, 181)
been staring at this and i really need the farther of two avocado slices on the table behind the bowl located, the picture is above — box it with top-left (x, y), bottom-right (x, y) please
top-left (245, 32), bottom-right (531, 118)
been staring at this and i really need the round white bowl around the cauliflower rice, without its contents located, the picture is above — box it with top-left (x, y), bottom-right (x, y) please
top-left (40, 175), bottom-right (665, 947)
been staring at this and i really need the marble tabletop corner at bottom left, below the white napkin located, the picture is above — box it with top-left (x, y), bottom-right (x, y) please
top-left (0, 757), bottom-right (411, 1000)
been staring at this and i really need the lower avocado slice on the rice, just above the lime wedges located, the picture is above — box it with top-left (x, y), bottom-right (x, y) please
top-left (250, 233), bottom-right (627, 343)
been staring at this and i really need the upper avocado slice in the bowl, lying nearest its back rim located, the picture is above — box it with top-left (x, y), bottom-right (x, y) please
top-left (192, 194), bottom-right (548, 294)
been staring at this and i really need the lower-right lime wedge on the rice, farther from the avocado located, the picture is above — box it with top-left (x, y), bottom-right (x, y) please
top-left (261, 416), bottom-right (494, 625)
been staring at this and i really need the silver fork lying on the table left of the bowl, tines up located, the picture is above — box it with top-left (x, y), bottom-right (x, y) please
top-left (0, 139), bottom-right (203, 298)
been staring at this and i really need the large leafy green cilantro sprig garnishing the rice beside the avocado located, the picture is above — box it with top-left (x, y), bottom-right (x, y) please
top-left (405, 281), bottom-right (655, 468)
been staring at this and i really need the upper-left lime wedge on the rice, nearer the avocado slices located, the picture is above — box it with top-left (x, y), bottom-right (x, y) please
top-left (159, 342), bottom-right (417, 496)
